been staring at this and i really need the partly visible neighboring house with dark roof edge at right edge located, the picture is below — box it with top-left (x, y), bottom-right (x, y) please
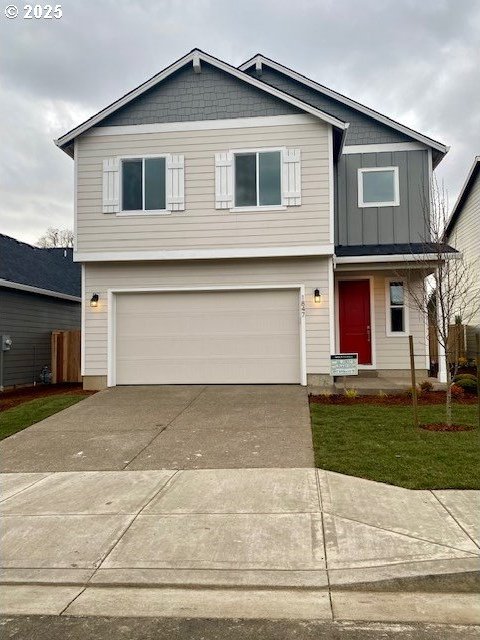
top-left (446, 156), bottom-right (480, 358)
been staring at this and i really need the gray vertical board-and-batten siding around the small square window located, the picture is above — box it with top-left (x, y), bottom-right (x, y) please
top-left (335, 151), bottom-right (428, 245)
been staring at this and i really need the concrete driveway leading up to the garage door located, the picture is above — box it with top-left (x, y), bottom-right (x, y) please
top-left (0, 385), bottom-right (313, 472)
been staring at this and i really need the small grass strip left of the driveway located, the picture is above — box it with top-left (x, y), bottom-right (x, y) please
top-left (0, 393), bottom-right (85, 440)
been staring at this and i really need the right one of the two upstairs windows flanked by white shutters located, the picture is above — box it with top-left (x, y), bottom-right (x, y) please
top-left (234, 151), bottom-right (282, 207)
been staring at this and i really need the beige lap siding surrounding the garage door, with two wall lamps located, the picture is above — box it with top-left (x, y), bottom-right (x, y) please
top-left (84, 258), bottom-right (331, 376)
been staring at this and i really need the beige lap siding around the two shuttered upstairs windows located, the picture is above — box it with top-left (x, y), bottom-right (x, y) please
top-left (75, 118), bottom-right (332, 254)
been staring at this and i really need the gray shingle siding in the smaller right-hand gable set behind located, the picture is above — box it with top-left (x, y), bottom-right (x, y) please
top-left (250, 65), bottom-right (412, 145)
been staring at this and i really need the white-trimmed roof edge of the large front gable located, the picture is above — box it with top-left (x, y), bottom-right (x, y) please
top-left (55, 49), bottom-right (348, 155)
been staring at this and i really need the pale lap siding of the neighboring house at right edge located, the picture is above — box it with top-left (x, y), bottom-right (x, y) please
top-left (449, 174), bottom-right (480, 355)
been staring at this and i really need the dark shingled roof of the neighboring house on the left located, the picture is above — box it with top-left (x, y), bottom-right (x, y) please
top-left (0, 234), bottom-right (81, 298)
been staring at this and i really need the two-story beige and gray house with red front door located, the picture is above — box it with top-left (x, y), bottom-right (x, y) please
top-left (56, 50), bottom-right (448, 389)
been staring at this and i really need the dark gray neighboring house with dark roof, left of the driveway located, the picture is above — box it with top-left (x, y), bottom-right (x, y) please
top-left (0, 234), bottom-right (81, 390)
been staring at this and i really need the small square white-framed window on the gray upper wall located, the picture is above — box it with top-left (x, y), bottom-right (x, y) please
top-left (358, 167), bottom-right (400, 207)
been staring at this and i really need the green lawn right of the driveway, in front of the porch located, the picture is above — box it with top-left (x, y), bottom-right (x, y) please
top-left (310, 404), bottom-right (480, 489)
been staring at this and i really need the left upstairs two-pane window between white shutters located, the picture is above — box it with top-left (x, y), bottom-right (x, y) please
top-left (121, 157), bottom-right (166, 213)
